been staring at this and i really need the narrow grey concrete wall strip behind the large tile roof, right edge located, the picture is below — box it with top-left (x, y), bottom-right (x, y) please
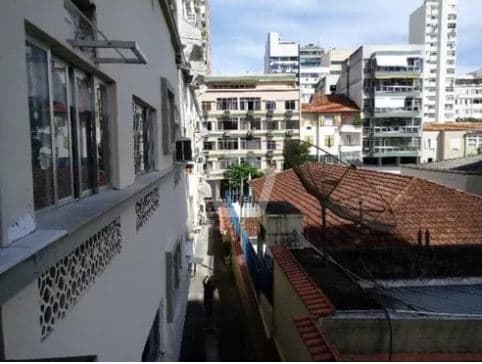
top-left (401, 166), bottom-right (482, 195)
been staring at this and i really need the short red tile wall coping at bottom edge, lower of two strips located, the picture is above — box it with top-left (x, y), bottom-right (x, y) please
top-left (294, 316), bottom-right (341, 361)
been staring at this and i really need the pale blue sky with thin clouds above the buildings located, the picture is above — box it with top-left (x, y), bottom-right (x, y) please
top-left (210, 0), bottom-right (482, 75)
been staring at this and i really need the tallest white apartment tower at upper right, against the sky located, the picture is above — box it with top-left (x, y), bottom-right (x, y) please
top-left (409, 0), bottom-right (457, 122)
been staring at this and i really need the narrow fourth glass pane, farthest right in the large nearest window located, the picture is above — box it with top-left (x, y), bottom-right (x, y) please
top-left (95, 83), bottom-right (110, 186)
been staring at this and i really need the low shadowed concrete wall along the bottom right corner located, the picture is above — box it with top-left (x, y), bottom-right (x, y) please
top-left (321, 313), bottom-right (482, 355)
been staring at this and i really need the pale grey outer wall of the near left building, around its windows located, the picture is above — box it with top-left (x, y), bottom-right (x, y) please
top-left (0, 0), bottom-right (194, 361)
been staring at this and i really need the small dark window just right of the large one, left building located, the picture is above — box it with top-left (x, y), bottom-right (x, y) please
top-left (133, 98), bottom-right (154, 176)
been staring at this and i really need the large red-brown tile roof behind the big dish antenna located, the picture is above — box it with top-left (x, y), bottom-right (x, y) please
top-left (250, 163), bottom-right (482, 247)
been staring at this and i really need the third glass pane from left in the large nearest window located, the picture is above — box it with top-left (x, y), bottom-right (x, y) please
top-left (76, 75), bottom-right (94, 191)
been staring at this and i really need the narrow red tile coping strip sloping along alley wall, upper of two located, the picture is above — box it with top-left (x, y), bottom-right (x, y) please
top-left (270, 245), bottom-right (335, 317)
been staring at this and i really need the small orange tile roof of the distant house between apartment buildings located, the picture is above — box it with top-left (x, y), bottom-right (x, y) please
top-left (301, 94), bottom-right (360, 114)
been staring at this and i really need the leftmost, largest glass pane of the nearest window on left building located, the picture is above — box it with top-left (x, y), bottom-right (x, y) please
top-left (26, 42), bottom-right (55, 209)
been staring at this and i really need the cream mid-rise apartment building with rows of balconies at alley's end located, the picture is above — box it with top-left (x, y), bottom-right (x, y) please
top-left (200, 74), bottom-right (300, 198)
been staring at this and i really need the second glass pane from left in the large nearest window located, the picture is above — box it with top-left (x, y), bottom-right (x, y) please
top-left (52, 60), bottom-right (73, 200)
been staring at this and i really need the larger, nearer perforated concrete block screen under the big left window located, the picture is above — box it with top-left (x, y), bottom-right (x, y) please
top-left (38, 217), bottom-right (121, 340)
